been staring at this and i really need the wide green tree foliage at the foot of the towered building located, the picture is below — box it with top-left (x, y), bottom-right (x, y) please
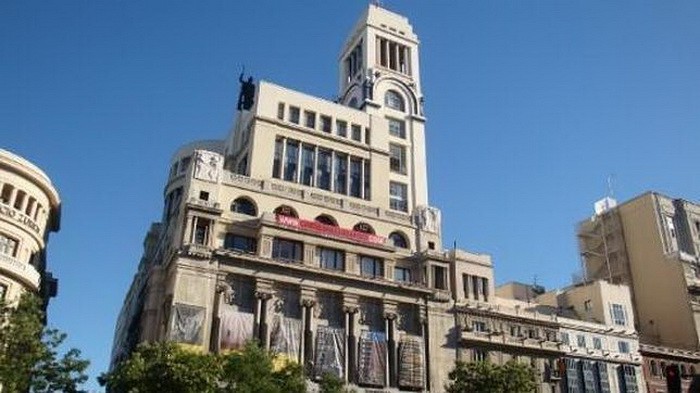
top-left (100, 342), bottom-right (306, 393)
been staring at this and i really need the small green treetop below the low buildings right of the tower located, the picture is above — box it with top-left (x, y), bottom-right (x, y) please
top-left (445, 360), bottom-right (537, 393)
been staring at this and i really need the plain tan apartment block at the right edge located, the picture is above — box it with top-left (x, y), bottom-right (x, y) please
top-left (577, 192), bottom-right (700, 392)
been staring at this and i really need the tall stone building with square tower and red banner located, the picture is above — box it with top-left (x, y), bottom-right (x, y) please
top-left (112, 5), bottom-right (484, 391)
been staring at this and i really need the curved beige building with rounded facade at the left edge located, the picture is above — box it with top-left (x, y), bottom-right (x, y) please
top-left (0, 149), bottom-right (61, 305)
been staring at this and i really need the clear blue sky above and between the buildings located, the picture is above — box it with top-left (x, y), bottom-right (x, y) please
top-left (0, 0), bottom-right (700, 387)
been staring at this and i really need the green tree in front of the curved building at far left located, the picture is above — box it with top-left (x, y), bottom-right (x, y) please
top-left (0, 293), bottom-right (90, 393)
